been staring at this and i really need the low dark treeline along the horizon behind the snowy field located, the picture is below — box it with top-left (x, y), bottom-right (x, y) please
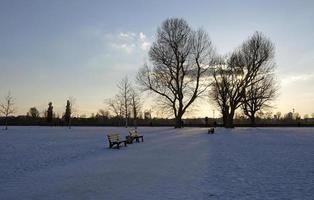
top-left (0, 113), bottom-right (314, 127)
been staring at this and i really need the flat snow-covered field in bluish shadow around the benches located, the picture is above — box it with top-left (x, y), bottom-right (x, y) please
top-left (0, 127), bottom-right (314, 200)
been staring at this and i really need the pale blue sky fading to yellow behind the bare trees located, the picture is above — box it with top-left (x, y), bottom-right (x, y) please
top-left (0, 0), bottom-right (314, 117)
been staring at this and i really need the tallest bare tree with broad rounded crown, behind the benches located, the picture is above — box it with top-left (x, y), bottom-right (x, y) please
top-left (137, 18), bottom-right (214, 128)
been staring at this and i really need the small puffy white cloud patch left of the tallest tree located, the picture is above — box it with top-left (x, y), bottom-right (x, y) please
top-left (84, 30), bottom-right (151, 78)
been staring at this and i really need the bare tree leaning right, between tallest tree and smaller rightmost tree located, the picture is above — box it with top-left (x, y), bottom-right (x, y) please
top-left (211, 32), bottom-right (274, 128)
